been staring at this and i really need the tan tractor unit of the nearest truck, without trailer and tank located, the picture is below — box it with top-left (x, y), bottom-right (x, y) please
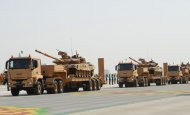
top-left (6, 56), bottom-right (66, 96)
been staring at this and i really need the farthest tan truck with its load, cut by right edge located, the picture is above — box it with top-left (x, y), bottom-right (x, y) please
top-left (164, 63), bottom-right (189, 84)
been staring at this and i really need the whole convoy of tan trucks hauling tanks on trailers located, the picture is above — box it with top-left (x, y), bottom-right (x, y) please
top-left (0, 50), bottom-right (190, 96)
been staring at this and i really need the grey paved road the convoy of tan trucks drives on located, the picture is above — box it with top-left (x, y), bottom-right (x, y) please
top-left (0, 84), bottom-right (190, 115)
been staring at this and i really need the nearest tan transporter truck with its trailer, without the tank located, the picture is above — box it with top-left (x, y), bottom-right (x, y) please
top-left (6, 51), bottom-right (104, 96)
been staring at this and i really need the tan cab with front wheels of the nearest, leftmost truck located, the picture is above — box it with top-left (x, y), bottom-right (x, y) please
top-left (6, 56), bottom-right (43, 96)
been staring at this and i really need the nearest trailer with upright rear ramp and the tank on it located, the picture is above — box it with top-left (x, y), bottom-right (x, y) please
top-left (35, 50), bottom-right (105, 92)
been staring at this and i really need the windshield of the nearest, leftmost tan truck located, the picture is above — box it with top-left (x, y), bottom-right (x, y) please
top-left (9, 59), bottom-right (31, 69)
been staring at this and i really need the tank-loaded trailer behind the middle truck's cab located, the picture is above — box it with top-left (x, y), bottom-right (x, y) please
top-left (129, 57), bottom-right (166, 86)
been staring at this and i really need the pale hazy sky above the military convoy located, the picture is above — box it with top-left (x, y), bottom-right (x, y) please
top-left (0, 0), bottom-right (190, 72)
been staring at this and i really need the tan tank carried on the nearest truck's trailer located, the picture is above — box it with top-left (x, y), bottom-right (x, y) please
top-left (35, 50), bottom-right (95, 77)
